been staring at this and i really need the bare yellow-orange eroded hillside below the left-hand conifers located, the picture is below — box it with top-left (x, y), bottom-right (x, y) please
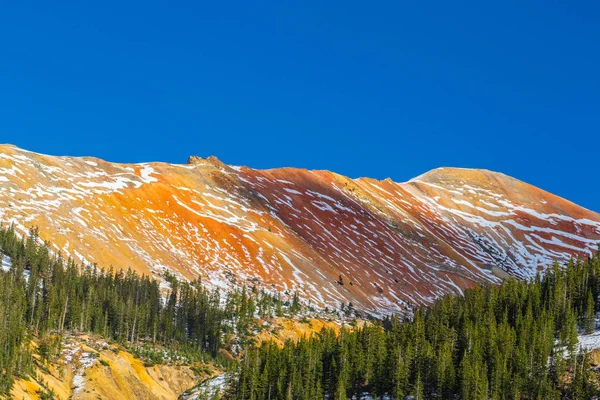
top-left (11, 335), bottom-right (214, 400)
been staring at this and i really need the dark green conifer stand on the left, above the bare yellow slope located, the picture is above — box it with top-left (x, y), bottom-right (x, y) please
top-left (0, 227), bottom-right (299, 396)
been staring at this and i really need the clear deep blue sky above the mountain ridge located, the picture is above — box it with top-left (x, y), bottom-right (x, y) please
top-left (0, 0), bottom-right (600, 211)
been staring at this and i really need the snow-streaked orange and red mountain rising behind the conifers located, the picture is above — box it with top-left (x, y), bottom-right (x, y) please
top-left (0, 145), bottom-right (600, 314)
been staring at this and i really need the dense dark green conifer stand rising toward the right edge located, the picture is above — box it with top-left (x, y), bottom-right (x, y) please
top-left (229, 248), bottom-right (600, 400)
